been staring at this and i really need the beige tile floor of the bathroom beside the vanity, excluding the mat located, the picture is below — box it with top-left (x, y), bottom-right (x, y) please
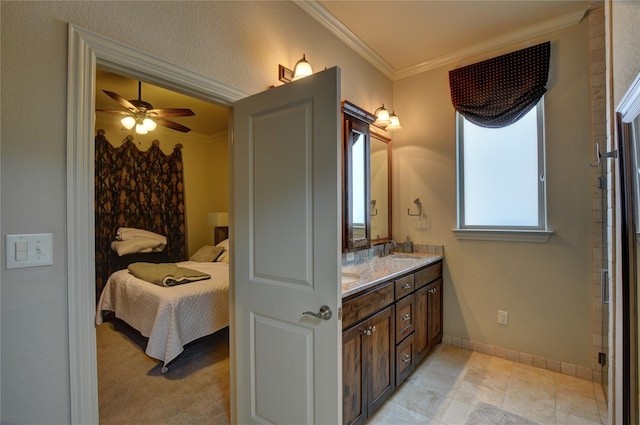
top-left (367, 344), bottom-right (607, 425)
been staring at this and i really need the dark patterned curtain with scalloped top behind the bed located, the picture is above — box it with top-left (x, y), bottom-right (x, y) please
top-left (95, 130), bottom-right (186, 297)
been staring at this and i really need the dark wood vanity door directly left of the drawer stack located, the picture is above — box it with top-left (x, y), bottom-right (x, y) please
top-left (363, 306), bottom-right (396, 416)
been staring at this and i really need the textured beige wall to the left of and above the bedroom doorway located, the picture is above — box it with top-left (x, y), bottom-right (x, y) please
top-left (0, 1), bottom-right (392, 424)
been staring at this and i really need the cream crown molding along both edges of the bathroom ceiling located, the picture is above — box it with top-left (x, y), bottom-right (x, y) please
top-left (294, 0), bottom-right (584, 81)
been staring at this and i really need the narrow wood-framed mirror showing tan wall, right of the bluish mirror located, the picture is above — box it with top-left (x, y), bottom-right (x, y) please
top-left (369, 126), bottom-right (393, 245)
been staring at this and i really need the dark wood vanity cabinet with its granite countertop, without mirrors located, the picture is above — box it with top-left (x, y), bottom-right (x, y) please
top-left (342, 253), bottom-right (442, 424)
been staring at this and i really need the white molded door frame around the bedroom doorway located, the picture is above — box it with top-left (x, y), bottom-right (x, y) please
top-left (66, 24), bottom-right (248, 424)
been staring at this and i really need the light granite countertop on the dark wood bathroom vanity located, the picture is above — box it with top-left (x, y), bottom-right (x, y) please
top-left (342, 253), bottom-right (443, 298)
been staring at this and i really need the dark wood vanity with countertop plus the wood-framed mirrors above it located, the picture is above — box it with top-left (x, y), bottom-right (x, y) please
top-left (342, 101), bottom-right (442, 424)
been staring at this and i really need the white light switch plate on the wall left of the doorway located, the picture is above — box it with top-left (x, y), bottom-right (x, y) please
top-left (5, 233), bottom-right (53, 269)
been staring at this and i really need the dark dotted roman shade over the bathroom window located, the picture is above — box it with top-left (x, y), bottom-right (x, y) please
top-left (449, 41), bottom-right (551, 128)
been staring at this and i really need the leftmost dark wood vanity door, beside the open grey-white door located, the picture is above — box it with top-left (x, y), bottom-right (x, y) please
top-left (342, 325), bottom-right (367, 425)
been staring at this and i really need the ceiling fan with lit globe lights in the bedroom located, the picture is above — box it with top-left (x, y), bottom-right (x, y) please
top-left (96, 81), bottom-right (195, 134)
